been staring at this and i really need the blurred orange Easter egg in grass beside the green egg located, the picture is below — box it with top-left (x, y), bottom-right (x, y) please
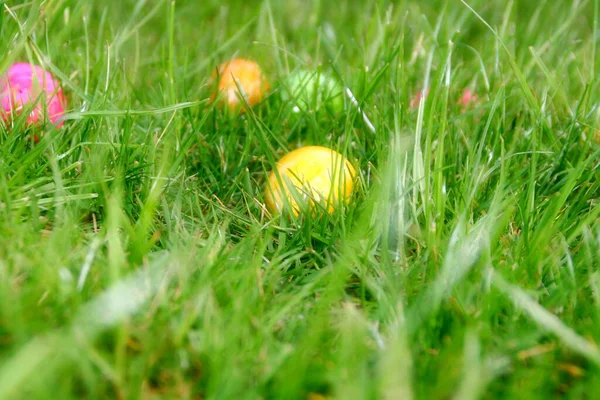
top-left (212, 58), bottom-right (270, 111)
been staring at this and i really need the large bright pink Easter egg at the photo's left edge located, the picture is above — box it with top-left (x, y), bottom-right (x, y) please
top-left (0, 63), bottom-right (67, 127)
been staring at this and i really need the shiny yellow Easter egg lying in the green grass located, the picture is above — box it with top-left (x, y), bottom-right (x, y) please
top-left (265, 146), bottom-right (356, 215)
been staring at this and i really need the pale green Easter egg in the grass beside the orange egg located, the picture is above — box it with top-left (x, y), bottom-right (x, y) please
top-left (279, 70), bottom-right (344, 115)
